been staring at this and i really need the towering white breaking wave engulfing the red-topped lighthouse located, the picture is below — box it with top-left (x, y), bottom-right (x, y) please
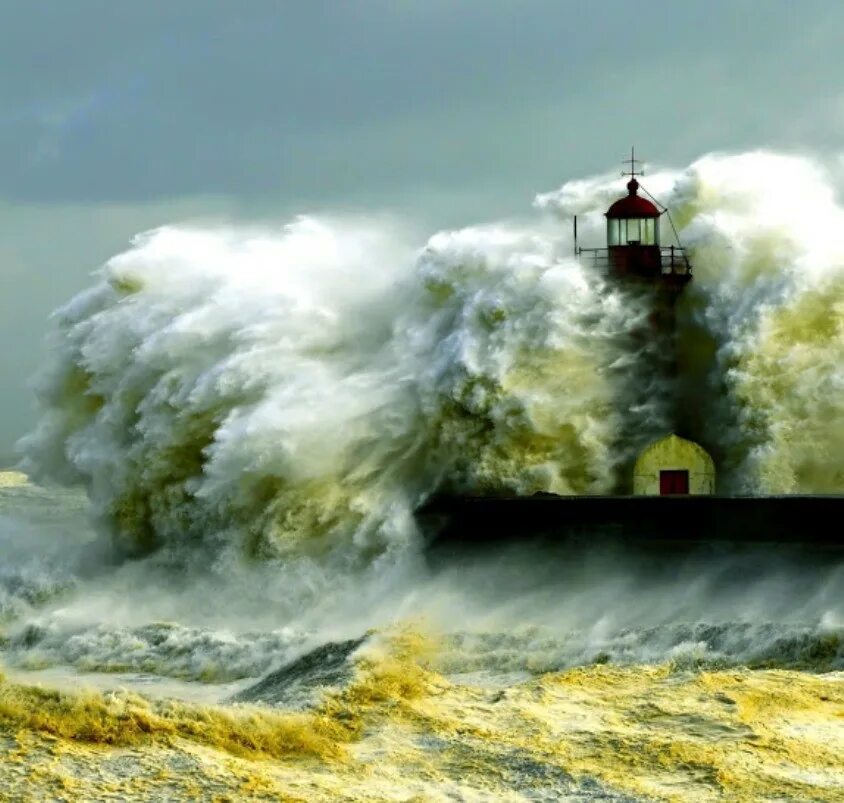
top-left (18, 152), bottom-right (844, 568)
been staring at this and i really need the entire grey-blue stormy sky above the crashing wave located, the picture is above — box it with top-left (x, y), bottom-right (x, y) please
top-left (0, 0), bottom-right (844, 458)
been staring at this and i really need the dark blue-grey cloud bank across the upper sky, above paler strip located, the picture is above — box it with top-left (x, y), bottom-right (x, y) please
top-left (0, 0), bottom-right (844, 202)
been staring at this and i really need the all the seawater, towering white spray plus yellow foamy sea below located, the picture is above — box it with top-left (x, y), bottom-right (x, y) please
top-left (0, 152), bottom-right (844, 801)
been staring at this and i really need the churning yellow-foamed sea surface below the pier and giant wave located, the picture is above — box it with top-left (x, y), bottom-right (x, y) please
top-left (0, 474), bottom-right (844, 801)
